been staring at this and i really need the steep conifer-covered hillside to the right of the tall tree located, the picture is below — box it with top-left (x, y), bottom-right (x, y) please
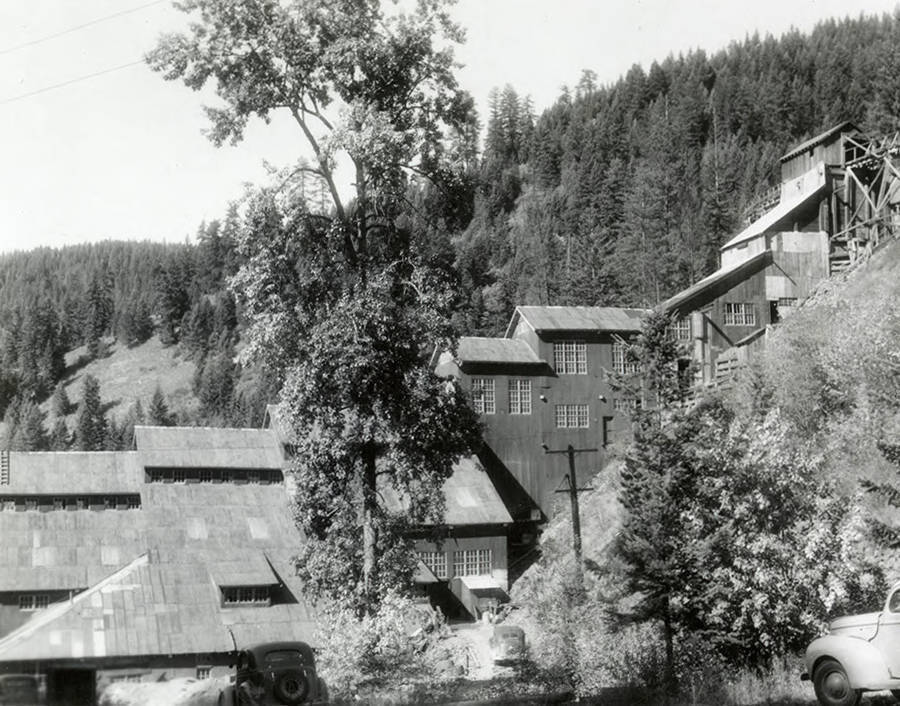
top-left (457, 10), bottom-right (900, 333)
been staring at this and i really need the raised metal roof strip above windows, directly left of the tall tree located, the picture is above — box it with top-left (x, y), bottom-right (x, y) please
top-left (134, 426), bottom-right (284, 469)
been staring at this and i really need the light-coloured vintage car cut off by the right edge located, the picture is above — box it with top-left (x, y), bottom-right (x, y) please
top-left (800, 583), bottom-right (900, 706)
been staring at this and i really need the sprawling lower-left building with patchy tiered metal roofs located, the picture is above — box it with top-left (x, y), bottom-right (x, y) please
top-left (0, 427), bottom-right (316, 704)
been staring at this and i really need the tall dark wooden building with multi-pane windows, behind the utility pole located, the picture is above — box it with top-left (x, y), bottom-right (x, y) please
top-left (435, 306), bottom-right (646, 524)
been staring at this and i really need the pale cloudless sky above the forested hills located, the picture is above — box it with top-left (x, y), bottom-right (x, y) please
top-left (0, 0), bottom-right (897, 252)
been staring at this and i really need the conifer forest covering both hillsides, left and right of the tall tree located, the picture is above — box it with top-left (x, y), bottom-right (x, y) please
top-left (0, 11), bottom-right (900, 448)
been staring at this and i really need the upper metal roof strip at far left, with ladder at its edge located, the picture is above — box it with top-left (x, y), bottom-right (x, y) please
top-left (0, 451), bottom-right (144, 495)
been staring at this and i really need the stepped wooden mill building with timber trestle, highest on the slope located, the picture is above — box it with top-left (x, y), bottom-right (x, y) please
top-left (663, 122), bottom-right (900, 384)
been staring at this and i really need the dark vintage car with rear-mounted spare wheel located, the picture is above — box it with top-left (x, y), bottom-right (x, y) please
top-left (219, 642), bottom-right (328, 706)
